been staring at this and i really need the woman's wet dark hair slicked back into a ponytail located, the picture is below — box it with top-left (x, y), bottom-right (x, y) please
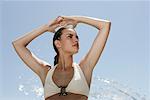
top-left (53, 27), bottom-right (66, 66)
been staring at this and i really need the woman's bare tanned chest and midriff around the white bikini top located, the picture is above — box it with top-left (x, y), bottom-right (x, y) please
top-left (45, 67), bottom-right (88, 100)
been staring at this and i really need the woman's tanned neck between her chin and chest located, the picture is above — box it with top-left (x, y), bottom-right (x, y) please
top-left (58, 54), bottom-right (73, 70)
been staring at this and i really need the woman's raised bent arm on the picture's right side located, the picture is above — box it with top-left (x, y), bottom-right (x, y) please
top-left (61, 16), bottom-right (111, 85)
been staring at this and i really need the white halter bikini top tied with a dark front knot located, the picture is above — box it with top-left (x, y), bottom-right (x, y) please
top-left (44, 63), bottom-right (89, 98)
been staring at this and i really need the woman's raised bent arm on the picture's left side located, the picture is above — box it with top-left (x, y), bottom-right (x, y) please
top-left (12, 18), bottom-right (63, 84)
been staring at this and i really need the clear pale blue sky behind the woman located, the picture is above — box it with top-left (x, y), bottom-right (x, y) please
top-left (0, 0), bottom-right (150, 100)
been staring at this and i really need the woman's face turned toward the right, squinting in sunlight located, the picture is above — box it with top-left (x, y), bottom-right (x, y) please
top-left (56, 29), bottom-right (79, 54)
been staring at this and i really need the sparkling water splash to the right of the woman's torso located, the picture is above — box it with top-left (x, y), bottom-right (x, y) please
top-left (89, 76), bottom-right (147, 100)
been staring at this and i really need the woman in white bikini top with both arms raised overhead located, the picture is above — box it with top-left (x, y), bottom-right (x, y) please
top-left (12, 16), bottom-right (110, 100)
